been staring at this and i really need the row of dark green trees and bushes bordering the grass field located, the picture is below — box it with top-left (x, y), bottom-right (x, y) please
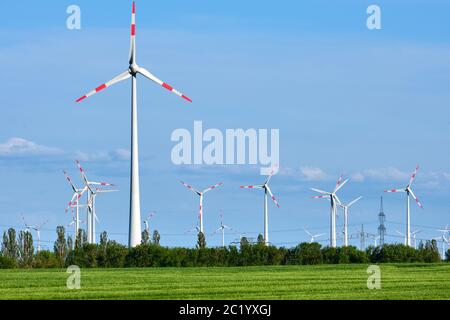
top-left (0, 227), bottom-right (450, 268)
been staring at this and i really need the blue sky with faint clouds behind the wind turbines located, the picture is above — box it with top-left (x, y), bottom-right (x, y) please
top-left (0, 0), bottom-right (450, 250)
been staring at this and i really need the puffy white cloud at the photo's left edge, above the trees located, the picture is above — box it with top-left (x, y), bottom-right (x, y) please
top-left (0, 138), bottom-right (64, 156)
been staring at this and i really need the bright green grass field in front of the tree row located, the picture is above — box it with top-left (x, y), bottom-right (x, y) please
top-left (0, 264), bottom-right (450, 299)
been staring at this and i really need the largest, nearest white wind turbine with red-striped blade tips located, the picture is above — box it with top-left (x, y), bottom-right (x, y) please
top-left (76, 1), bottom-right (192, 247)
